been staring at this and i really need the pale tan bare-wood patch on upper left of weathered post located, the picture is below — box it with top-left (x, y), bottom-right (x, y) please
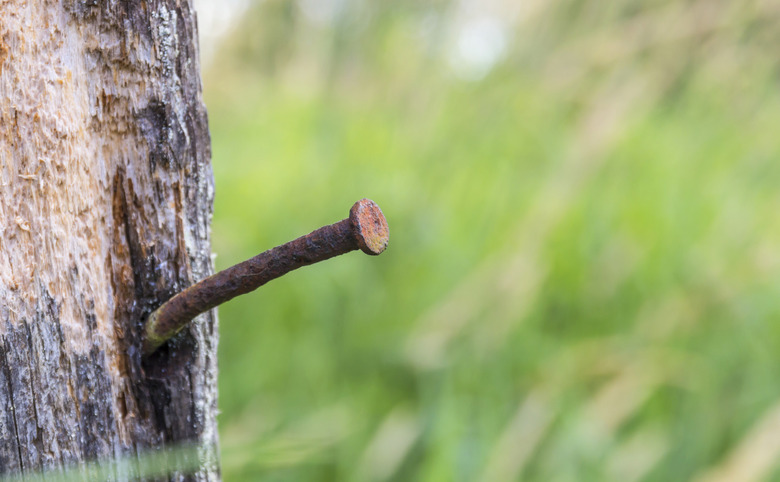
top-left (0, 2), bottom-right (113, 353)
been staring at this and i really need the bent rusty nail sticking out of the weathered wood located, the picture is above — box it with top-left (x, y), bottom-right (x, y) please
top-left (143, 199), bottom-right (390, 355)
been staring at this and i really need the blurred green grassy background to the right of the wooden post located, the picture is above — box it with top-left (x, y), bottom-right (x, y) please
top-left (200, 0), bottom-right (780, 481)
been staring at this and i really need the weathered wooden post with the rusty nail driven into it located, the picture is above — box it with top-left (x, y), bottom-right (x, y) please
top-left (0, 0), bottom-right (219, 480)
